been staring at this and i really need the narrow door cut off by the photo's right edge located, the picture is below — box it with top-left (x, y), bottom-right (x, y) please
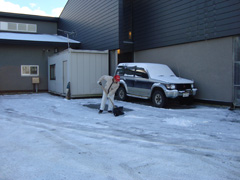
top-left (234, 37), bottom-right (240, 106)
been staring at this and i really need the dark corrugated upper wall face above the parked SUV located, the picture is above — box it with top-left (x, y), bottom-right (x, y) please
top-left (133, 0), bottom-right (240, 51)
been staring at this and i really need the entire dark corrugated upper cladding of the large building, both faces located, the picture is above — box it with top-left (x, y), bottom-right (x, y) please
top-left (59, 0), bottom-right (240, 52)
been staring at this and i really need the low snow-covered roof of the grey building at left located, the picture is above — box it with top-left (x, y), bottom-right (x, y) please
top-left (0, 32), bottom-right (80, 44)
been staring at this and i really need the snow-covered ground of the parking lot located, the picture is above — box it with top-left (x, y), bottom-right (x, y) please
top-left (0, 93), bottom-right (240, 180)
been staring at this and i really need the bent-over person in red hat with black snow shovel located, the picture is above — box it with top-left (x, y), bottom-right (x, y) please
top-left (97, 75), bottom-right (124, 116)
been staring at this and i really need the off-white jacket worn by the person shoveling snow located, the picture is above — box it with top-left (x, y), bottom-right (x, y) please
top-left (98, 75), bottom-right (119, 96)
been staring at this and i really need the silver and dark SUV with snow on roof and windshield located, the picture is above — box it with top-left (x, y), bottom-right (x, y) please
top-left (115, 63), bottom-right (197, 107)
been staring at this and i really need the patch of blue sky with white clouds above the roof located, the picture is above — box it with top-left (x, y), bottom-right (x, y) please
top-left (0, 0), bottom-right (68, 17)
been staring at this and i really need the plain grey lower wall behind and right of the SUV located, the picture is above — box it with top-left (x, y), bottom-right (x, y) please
top-left (134, 37), bottom-right (233, 102)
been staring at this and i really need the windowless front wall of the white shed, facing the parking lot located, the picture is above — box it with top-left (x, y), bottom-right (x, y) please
top-left (70, 51), bottom-right (109, 97)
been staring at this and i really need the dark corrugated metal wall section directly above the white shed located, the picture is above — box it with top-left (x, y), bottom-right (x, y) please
top-left (59, 0), bottom-right (119, 50)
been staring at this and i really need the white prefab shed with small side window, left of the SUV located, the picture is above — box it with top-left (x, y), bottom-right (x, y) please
top-left (48, 49), bottom-right (109, 98)
